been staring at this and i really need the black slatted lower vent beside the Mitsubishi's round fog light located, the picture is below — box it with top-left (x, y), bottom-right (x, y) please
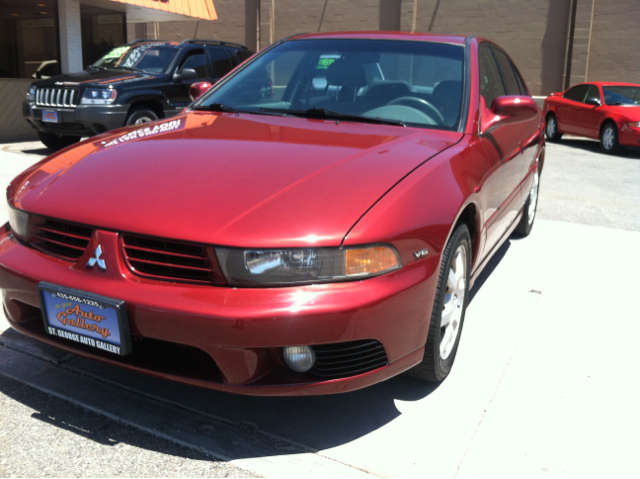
top-left (310, 339), bottom-right (389, 379)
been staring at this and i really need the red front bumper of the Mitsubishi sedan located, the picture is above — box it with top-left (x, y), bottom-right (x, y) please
top-left (0, 225), bottom-right (439, 395)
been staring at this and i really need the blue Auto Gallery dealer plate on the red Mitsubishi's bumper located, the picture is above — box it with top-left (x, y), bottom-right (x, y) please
top-left (38, 283), bottom-right (131, 356)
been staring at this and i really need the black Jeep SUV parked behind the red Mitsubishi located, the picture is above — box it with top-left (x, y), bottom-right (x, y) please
top-left (22, 40), bottom-right (253, 150)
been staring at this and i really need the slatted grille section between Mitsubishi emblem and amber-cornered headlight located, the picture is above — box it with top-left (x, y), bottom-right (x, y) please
top-left (122, 235), bottom-right (217, 284)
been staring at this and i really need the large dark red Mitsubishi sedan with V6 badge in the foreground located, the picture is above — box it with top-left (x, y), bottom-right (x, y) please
top-left (0, 32), bottom-right (544, 395)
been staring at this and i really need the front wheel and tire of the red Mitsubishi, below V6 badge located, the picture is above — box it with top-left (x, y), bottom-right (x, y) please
top-left (407, 225), bottom-right (471, 381)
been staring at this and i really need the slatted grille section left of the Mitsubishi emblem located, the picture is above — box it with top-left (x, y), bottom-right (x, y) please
top-left (29, 217), bottom-right (93, 261)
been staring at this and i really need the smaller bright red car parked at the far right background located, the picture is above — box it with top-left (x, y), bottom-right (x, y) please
top-left (544, 82), bottom-right (640, 153)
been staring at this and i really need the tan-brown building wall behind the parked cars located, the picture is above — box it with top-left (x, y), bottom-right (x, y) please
top-left (129, 0), bottom-right (640, 95)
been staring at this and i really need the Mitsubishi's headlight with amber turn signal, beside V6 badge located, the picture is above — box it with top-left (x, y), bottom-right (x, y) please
top-left (216, 245), bottom-right (402, 286)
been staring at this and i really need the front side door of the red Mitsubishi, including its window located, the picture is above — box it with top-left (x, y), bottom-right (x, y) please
top-left (478, 43), bottom-right (535, 252)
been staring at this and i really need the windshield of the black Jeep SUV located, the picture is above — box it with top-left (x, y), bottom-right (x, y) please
top-left (91, 43), bottom-right (177, 73)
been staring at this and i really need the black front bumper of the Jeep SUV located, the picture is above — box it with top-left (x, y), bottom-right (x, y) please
top-left (22, 101), bottom-right (129, 136)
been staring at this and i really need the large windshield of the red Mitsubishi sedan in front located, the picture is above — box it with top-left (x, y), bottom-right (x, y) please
top-left (193, 39), bottom-right (464, 130)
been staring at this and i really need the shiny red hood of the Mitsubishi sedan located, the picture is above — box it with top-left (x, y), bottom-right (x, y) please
top-left (9, 112), bottom-right (462, 248)
